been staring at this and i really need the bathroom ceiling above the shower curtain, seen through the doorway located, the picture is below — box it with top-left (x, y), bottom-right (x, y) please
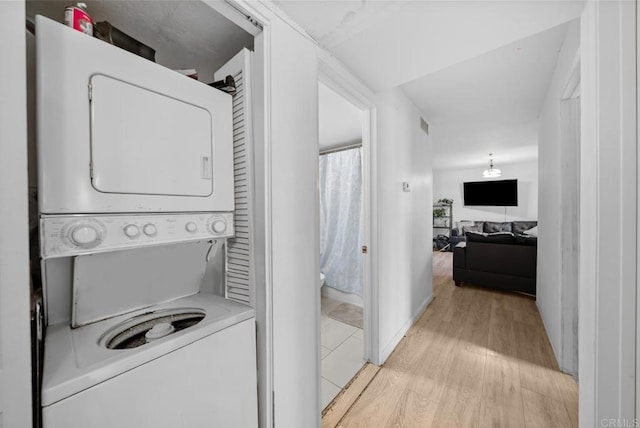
top-left (318, 83), bottom-right (362, 151)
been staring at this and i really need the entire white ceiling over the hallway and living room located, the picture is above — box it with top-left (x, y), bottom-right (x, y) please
top-left (275, 0), bottom-right (584, 169)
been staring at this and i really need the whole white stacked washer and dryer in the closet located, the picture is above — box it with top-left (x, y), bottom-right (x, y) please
top-left (36, 16), bottom-right (257, 428)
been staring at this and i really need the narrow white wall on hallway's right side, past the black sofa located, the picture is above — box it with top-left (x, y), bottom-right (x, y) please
top-left (536, 21), bottom-right (580, 368)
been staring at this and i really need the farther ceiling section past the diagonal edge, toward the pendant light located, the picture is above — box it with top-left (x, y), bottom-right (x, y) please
top-left (402, 24), bottom-right (567, 169)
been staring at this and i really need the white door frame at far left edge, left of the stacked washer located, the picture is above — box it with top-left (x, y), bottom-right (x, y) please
top-left (0, 0), bottom-right (32, 428)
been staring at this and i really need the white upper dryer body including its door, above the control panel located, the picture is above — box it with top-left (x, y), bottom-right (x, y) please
top-left (36, 16), bottom-right (234, 214)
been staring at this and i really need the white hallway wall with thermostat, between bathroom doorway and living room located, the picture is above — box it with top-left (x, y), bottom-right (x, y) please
top-left (373, 89), bottom-right (433, 363)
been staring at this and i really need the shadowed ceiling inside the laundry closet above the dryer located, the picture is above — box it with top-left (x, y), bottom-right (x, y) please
top-left (26, 0), bottom-right (253, 82)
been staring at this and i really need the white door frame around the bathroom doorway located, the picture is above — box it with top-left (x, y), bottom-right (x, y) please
top-left (318, 59), bottom-right (380, 364)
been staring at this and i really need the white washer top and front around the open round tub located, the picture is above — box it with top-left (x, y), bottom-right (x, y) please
top-left (42, 295), bottom-right (257, 428)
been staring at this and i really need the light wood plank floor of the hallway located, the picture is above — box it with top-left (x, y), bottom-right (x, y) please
top-left (323, 253), bottom-right (578, 428)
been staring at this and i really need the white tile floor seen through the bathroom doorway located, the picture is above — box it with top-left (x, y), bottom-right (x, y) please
top-left (320, 297), bottom-right (365, 409)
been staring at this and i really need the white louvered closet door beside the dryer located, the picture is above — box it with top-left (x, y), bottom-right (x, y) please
top-left (215, 49), bottom-right (255, 307)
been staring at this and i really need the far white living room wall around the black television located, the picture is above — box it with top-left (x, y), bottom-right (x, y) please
top-left (433, 161), bottom-right (538, 225)
